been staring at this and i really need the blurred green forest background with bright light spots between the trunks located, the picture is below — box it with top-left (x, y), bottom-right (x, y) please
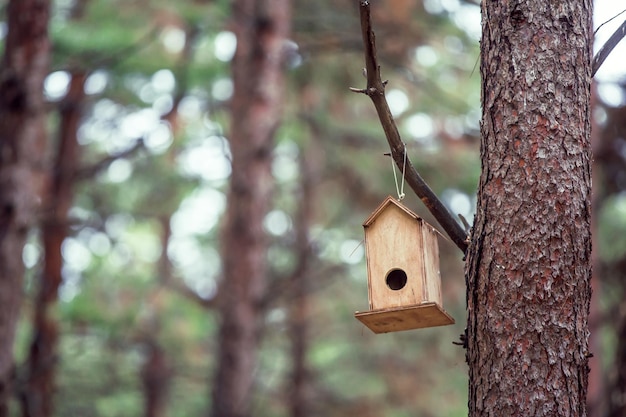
top-left (0, 0), bottom-right (626, 417)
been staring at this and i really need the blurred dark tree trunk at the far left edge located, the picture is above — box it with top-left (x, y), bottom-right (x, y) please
top-left (0, 0), bottom-right (50, 416)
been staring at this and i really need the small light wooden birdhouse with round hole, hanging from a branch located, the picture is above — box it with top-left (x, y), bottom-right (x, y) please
top-left (355, 197), bottom-right (454, 333)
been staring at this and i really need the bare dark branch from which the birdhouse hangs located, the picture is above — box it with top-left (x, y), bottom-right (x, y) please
top-left (350, 0), bottom-right (467, 253)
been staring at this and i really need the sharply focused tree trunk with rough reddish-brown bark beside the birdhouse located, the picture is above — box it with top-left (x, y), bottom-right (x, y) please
top-left (466, 0), bottom-right (592, 416)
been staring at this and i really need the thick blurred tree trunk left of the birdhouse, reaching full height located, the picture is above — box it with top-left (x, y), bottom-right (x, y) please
top-left (211, 0), bottom-right (290, 417)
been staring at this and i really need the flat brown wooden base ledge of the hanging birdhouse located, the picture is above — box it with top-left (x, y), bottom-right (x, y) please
top-left (354, 302), bottom-right (454, 334)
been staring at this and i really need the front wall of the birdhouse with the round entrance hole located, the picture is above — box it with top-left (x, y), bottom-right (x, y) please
top-left (365, 205), bottom-right (425, 310)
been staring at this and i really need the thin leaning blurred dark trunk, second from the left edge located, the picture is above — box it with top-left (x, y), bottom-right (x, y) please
top-left (21, 72), bottom-right (87, 417)
